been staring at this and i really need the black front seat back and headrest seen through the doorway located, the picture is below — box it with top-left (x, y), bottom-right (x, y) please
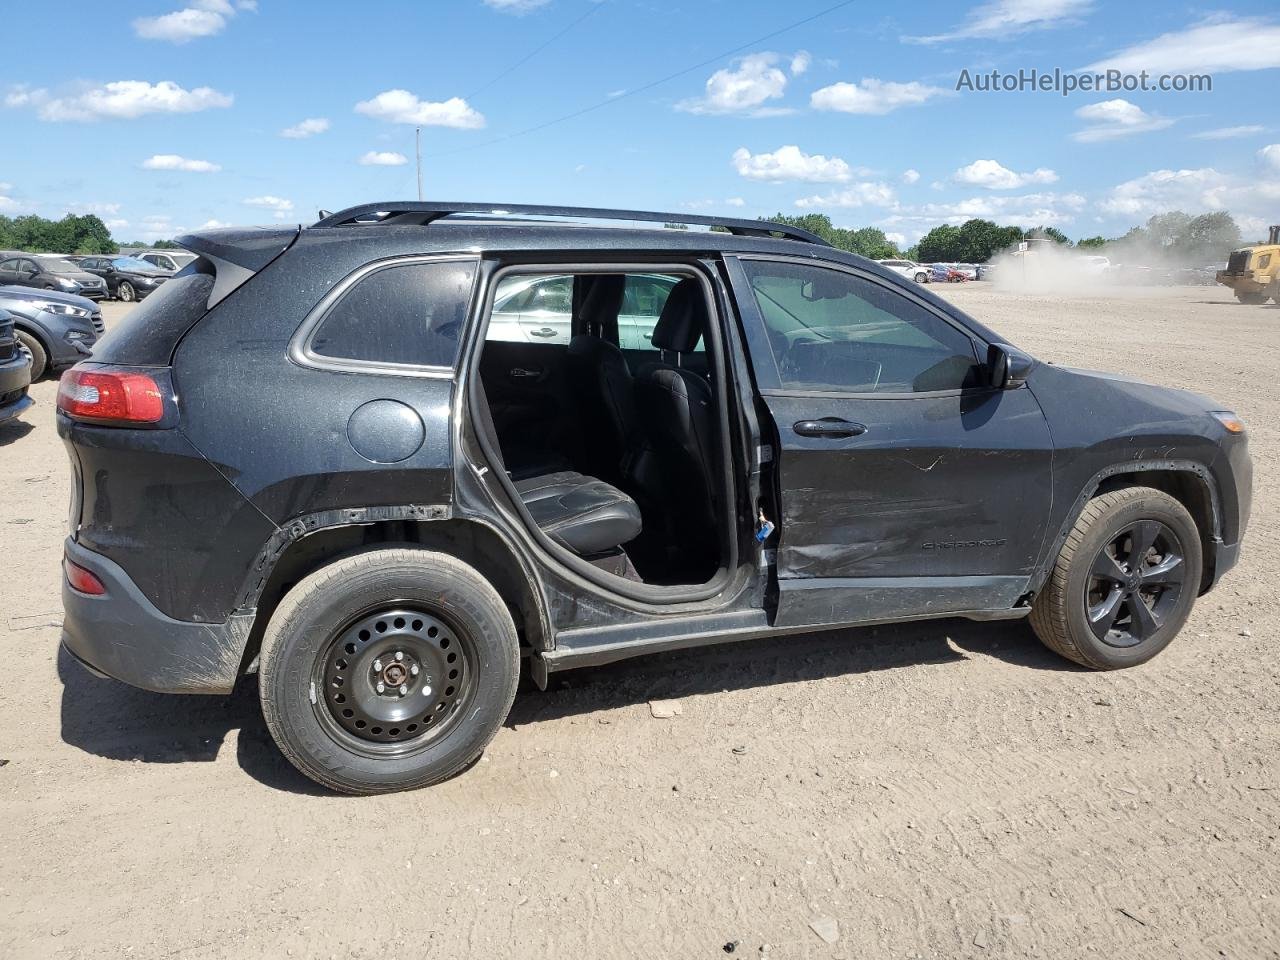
top-left (635, 278), bottom-right (718, 557)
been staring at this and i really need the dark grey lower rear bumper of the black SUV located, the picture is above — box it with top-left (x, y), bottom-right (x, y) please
top-left (63, 540), bottom-right (253, 694)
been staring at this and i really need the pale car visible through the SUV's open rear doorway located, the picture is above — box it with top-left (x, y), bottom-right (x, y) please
top-left (488, 274), bottom-right (678, 349)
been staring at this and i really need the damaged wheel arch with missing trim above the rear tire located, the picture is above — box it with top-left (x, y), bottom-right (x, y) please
top-left (236, 507), bottom-right (552, 673)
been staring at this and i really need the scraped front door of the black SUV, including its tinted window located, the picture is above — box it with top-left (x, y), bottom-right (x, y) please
top-left (731, 257), bottom-right (1052, 626)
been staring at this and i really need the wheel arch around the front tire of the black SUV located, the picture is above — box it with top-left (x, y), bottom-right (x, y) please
top-left (1033, 460), bottom-right (1222, 593)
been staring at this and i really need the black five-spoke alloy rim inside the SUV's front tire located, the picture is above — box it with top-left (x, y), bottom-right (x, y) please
top-left (1084, 520), bottom-right (1187, 648)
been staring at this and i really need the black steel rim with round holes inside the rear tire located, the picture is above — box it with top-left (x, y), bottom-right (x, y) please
top-left (312, 604), bottom-right (474, 756)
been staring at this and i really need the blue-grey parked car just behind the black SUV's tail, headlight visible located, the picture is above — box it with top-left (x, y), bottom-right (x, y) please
top-left (0, 287), bottom-right (105, 381)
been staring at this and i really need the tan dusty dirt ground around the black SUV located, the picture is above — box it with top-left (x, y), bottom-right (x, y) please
top-left (0, 284), bottom-right (1280, 959)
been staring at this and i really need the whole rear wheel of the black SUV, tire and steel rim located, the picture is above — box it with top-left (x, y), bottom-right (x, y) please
top-left (259, 548), bottom-right (520, 794)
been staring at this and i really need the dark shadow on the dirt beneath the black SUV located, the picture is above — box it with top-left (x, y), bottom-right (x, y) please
top-left (58, 621), bottom-right (1076, 797)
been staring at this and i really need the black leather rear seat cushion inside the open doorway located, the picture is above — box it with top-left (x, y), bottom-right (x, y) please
top-left (516, 471), bottom-right (641, 557)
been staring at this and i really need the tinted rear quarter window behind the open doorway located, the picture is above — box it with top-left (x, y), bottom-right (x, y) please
top-left (308, 260), bottom-right (476, 366)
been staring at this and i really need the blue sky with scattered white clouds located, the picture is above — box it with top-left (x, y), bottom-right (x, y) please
top-left (0, 0), bottom-right (1280, 243)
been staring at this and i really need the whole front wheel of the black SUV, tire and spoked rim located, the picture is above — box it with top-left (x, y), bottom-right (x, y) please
top-left (1030, 486), bottom-right (1203, 669)
